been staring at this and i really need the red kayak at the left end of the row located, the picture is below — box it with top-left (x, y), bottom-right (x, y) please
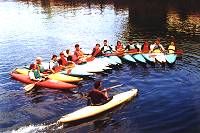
top-left (10, 73), bottom-right (77, 89)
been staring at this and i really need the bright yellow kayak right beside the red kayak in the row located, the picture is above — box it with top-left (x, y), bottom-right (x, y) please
top-left (15, 68), bottom-right (83, 82)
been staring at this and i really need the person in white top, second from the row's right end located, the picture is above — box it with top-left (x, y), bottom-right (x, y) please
top-left (150, 38), bottom-right (165, 53)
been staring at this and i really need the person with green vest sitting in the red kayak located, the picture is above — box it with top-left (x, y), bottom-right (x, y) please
top-left (28, 64), bottom-right (48, 81)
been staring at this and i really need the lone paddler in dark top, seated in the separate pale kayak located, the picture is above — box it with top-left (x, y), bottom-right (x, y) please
top-left (87, 81), bottom-right (109, 105)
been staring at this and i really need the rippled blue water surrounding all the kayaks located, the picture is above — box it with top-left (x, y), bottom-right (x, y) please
top-left (0, 0), bottom-right (200, 133)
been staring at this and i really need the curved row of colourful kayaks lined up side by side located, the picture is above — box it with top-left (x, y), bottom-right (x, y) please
top-left (11, 53), bottom-right (183, 89)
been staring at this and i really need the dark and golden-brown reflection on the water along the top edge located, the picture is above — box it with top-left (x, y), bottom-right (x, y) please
top-left (18, 0), bottom-right (200, 39)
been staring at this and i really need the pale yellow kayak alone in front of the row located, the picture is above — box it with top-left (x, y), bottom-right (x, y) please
top-left (58, 89), bottom-right (138, 123)
